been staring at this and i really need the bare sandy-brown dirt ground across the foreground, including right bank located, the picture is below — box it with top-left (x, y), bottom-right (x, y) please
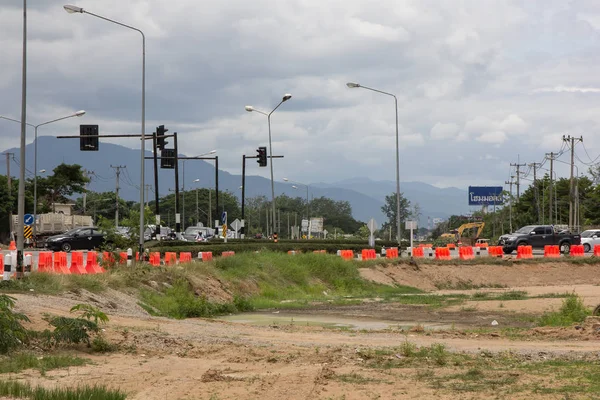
top-left (3, 263), bottom-right (600, 400)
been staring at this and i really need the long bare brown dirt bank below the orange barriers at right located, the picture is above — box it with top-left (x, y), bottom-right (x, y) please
top-left (360, 262), bottom-right (600, 290)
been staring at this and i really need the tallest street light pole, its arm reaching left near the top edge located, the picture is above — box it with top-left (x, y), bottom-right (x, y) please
top-left (64, 4), bottom-right (146, 256)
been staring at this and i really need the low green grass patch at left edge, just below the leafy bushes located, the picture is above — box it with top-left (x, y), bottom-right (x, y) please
top-left (0, 353), bottom-right (91, 374)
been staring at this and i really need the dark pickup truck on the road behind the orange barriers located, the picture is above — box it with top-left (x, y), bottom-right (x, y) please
top-left (498, 225), bottom-right (581, 254)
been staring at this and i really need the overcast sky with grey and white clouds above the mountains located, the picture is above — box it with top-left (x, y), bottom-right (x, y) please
top-left (0, 0), bottom-right (600, 191)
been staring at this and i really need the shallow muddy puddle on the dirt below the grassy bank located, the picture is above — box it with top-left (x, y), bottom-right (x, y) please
top-left (217, 312), bottom-right (452, 330)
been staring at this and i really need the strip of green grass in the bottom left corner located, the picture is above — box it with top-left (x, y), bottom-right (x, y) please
top-left (0, 381), bottom-right (127, 400)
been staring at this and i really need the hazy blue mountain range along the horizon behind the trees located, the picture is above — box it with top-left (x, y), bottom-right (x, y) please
top-left (0, 136), bottom-right (469, 226)
